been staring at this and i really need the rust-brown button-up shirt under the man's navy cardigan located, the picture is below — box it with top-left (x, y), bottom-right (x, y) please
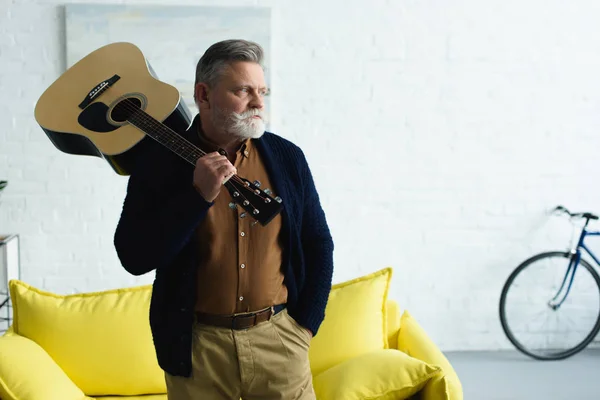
top-left (195, 126), bottom-right (287, 314)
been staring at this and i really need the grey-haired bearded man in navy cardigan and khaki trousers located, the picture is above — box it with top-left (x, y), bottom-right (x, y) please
top-left (115, 40), bottom-right (333, 400)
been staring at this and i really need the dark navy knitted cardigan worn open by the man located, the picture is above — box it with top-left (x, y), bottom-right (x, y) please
top-left (114, 118), bottom-right (333, 376)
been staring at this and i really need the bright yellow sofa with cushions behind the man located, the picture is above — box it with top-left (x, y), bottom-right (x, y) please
top-left (0, 268), bottom-right (463, 400)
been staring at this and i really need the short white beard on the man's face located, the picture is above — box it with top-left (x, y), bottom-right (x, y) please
top-left (213, 108), bottom-right (265, 140)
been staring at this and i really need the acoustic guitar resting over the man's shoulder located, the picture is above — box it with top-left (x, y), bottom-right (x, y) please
top-left (35, 42), bottom-right (283, 225)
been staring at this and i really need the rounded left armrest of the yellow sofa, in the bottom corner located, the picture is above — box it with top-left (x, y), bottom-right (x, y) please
top-left (0, 333), bottom-right (87, 400)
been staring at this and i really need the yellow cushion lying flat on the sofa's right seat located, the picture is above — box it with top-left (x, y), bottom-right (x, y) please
top-left (313, 349), bottom-right (440, 400)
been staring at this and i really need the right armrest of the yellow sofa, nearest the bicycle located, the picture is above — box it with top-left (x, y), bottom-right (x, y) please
top-left (398, 310), bottom-right (463, 400)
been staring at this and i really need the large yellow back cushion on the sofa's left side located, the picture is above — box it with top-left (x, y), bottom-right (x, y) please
top-left (9, 280), bottom-right (166, 396)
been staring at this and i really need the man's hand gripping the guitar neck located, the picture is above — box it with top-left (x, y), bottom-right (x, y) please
top-left (194, 151), bottom-right (237, 202)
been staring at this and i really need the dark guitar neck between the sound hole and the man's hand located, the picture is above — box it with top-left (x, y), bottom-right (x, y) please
top-left (127, 105), bottom-right (206, 165)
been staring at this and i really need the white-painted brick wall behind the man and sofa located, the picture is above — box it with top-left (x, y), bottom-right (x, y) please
top-left (0, 0), bottom-right (600, 350)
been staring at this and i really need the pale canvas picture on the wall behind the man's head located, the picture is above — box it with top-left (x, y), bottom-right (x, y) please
top-left (65, 4), bottom-right (271, 119)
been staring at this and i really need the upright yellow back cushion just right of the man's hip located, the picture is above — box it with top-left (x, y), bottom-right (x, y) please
top-left (309, 268), bottom-right (392, 376)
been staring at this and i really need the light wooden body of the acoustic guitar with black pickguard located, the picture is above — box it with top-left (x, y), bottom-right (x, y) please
top-left (35, 42), bottom-right (191, 175)
